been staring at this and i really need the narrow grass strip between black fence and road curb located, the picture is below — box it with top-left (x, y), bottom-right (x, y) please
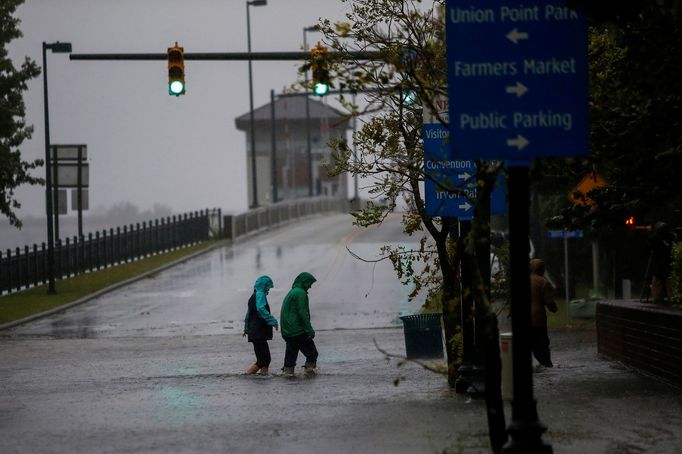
top-left (0, 241), bottom-right (216, 324)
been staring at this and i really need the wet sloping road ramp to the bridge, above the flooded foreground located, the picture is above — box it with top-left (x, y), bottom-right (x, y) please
top-left (13, 215), bottom-right (421, 338)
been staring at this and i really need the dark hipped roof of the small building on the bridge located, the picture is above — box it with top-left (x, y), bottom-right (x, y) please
top-left (235, 96), bottom-right (350, 131)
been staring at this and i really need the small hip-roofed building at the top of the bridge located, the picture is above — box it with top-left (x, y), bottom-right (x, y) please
top-left (235, 96), bottom-right (350, 205)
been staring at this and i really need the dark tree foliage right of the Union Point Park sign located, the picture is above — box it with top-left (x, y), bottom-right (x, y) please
top-left (536, 0), bottom-right (682, 230)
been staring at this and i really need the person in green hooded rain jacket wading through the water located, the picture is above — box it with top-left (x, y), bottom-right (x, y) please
top-left (280, 272), bottom-right (317, 377)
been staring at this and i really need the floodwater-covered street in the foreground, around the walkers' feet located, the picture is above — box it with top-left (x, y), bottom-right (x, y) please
top-left (0, 328), bottom-right (682, 454)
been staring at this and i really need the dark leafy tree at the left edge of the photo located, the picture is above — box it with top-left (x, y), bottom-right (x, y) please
top-left (0, 0), bottom-right (43, 228)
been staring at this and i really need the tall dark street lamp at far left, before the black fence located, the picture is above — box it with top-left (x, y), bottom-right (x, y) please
top-left (43, 41), bottom-right (71, 294)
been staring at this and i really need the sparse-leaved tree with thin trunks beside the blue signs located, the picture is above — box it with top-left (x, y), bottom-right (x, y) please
top-left (314, 0), bottom-right (506, 452)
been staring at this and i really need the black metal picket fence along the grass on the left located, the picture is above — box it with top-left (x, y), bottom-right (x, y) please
top-left (0, 209), bottom-right (216, 294)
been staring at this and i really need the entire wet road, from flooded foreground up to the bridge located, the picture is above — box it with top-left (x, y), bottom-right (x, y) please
top-left (0, 216), bottom-right (682, 454)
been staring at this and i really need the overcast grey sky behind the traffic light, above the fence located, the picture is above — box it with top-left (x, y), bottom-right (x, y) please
top-left (9, 0), bottom-right (347, 215)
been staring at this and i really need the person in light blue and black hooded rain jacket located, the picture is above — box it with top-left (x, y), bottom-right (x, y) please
top-left (243, 276), bottom-right (278, 375)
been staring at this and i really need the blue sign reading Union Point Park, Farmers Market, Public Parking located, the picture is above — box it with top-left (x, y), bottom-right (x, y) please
top-left (446, 0), bottom-right (589, 160)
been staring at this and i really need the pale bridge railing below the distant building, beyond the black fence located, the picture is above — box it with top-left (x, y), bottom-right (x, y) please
top-left (222, 197), bottom-right (349, 240)
